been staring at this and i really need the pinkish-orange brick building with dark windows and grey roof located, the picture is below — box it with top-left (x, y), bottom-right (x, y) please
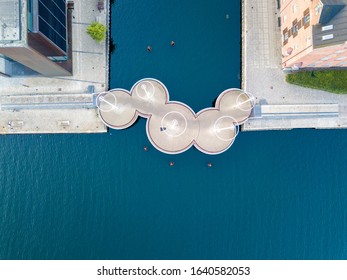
top-left (281, 0), bottom-right (347, 70)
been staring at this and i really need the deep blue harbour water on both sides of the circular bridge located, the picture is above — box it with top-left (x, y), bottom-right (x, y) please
top-left (0, 0), bottom-right (347, 259)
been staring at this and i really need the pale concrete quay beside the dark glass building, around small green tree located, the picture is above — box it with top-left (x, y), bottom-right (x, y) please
top-left (0, 0), bottom-right (110, 134)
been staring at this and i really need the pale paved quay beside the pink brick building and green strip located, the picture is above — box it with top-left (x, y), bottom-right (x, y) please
top-left (242, 0), bottom-right (347, 131)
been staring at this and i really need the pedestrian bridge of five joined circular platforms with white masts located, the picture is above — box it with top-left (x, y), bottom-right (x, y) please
top-left (96, 78), bottom-right (255, 155)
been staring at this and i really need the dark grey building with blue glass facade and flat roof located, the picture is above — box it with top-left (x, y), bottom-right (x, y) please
top-left (0, 0), bottom-right (72, 77)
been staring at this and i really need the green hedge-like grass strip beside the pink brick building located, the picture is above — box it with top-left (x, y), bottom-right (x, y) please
top-left (286, 70), bottom-right (347, 94)
